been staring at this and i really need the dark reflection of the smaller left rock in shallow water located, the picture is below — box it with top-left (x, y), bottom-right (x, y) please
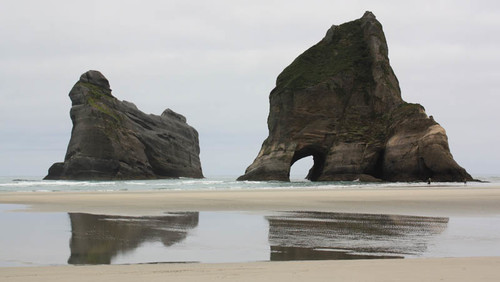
top-left (68, 212), bottom-right (199, 264)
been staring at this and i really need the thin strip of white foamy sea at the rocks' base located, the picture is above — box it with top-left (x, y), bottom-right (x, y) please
top-left (0, 175), bottom-right (500, 192)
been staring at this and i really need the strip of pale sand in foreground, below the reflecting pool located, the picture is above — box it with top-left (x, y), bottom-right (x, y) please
top-left (0, 257), bottom-right (500, 282)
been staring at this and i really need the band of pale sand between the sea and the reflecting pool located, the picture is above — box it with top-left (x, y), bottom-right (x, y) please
top-left (0, 185), bottom-right (500, 216)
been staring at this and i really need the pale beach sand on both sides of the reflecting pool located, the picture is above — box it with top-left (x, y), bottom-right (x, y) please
top-left (0, 186), bottom-right (500, 281)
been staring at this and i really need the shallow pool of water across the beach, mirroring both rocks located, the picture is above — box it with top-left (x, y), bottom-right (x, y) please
top-left (0, 205), bottom-right (500, 267)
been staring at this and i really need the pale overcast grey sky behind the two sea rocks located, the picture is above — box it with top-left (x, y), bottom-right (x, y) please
top-left (0, 0), bottom-right (500, 176)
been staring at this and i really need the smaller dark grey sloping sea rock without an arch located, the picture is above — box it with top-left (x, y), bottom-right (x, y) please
top-left (45, 71), bottom-right (203, 180)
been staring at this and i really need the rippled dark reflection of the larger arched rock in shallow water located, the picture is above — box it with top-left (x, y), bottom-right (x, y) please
top-left (266, 212), bottom-right (449, 260)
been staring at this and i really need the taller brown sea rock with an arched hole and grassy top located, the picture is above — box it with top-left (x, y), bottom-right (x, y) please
top-left (238, 12), bottom-right (472, 181)
